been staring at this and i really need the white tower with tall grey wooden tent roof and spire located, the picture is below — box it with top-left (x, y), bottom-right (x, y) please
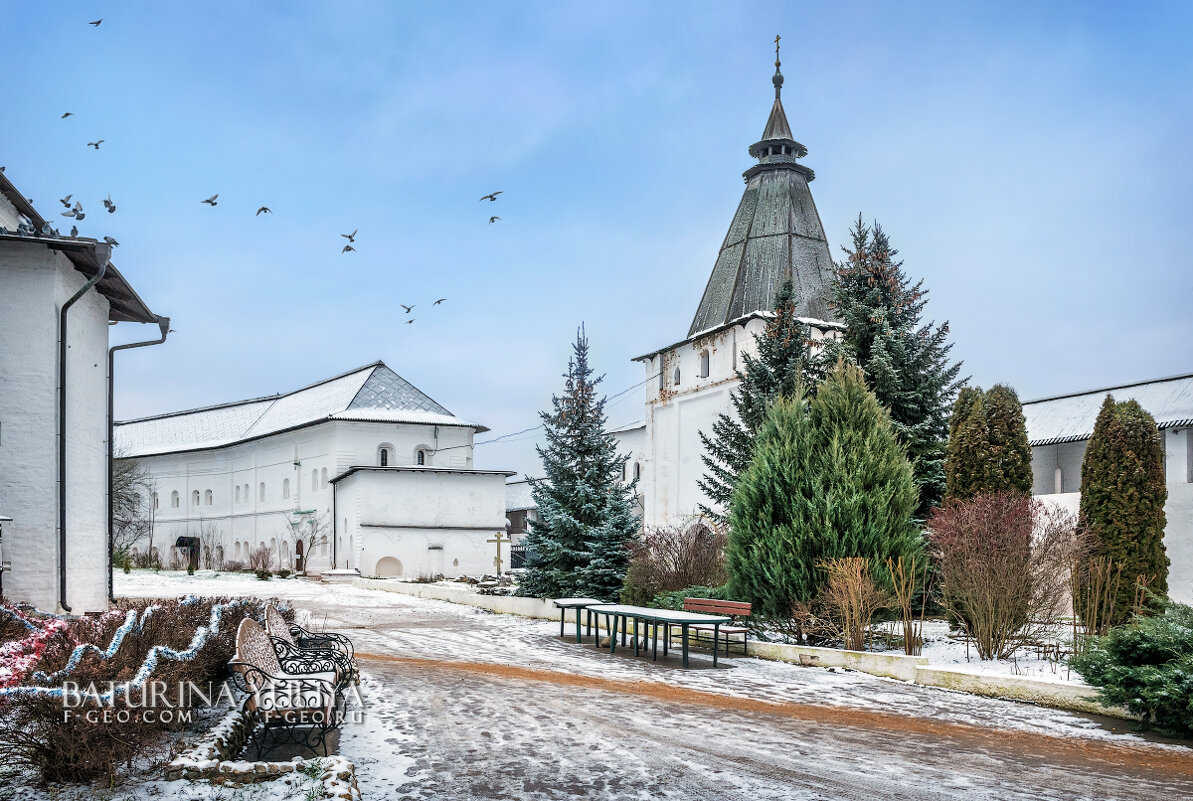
top-left (614, 54), bottom-right (841, 526)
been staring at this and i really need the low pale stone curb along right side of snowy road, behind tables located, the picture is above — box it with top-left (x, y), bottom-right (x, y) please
top-left (352, 579), bottom-right (1138, 720)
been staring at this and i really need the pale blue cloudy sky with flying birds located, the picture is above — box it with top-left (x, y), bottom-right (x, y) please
top-left (0, 0), bottom-right (1193, 475)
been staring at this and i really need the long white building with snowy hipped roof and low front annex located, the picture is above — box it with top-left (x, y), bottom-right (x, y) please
top-left (116, 362), bottom-right (512, 577)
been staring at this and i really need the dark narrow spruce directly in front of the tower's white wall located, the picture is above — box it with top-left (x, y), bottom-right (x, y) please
top-left (699, 278), bottom-right (823, 520)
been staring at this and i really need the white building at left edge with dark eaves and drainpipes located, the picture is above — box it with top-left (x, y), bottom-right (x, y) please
top-left (0, 173), bottom-right (160, 614)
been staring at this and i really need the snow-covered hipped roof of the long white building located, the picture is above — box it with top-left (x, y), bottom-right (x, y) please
top-left (115, 362), bottom-right (488, 456)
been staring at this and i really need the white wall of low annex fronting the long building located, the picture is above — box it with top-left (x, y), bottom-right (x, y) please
top-left (339, 470), bottom-right (509, 578)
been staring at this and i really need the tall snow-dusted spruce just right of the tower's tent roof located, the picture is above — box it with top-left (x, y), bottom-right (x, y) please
top-left (828, 215), bottom-right (963, 520)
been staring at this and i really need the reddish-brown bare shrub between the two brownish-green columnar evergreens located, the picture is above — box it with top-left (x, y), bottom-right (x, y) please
top-left (928, 493), bottom-right (1084, 659)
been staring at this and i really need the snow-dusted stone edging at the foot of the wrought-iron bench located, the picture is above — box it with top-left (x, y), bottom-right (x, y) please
top-left (166, 700), bottom-right (360, 801)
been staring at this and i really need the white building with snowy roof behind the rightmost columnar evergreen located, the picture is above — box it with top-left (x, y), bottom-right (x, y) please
top-left (1024, 374), bottom-right (1193, 603)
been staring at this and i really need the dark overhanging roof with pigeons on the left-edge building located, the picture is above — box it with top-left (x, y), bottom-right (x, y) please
top-left (0, 172), bottom-right (157, 322)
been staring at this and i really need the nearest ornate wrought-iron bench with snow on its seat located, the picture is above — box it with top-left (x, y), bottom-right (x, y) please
top-left (228, 617), bottom-right (344, 759)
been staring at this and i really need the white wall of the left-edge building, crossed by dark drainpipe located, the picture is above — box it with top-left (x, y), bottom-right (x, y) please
top-left (0, 241), bottom-right (109, 612)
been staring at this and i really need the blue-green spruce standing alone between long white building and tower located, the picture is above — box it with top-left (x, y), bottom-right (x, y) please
top-left (520, 328), bottom-right (639, 599)
